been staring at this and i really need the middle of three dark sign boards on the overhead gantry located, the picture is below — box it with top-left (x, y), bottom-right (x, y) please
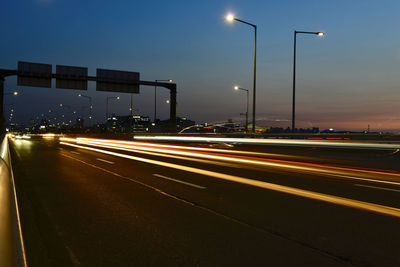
top-left (56, 65), bottom-right (88, 90)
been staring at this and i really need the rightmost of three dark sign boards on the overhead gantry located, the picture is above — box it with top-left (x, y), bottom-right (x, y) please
top-left (96, 69), bottom-right (140, 94)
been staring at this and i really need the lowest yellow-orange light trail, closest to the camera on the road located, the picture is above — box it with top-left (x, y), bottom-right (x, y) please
top-left (60, 142), bottom-right (400, 218)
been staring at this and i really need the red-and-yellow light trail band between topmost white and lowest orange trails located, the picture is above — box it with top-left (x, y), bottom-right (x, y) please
top-left (61, 138), bottom-right (400, 186)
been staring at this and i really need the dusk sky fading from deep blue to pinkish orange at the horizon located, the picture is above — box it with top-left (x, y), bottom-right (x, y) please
top-left (0, 0), bottom-right (400, 131)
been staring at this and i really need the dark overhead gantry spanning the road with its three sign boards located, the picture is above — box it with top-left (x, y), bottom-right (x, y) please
top-left (0, 61), bottom-right (176, 131)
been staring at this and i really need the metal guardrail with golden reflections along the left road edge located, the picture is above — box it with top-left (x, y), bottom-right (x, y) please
top-left (0, 135), bottom-right (27, 267)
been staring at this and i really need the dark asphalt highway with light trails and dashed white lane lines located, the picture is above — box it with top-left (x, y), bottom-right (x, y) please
top-left (10, 136), bottom-right (400, 266)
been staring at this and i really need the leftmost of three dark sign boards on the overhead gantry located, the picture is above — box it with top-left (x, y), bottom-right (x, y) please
top-left (17, 61), bottom-right (52, 88)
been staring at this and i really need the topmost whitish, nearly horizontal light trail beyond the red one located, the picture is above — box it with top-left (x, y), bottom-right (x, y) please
top-left (134, 136), bottom-right (400, 150)
